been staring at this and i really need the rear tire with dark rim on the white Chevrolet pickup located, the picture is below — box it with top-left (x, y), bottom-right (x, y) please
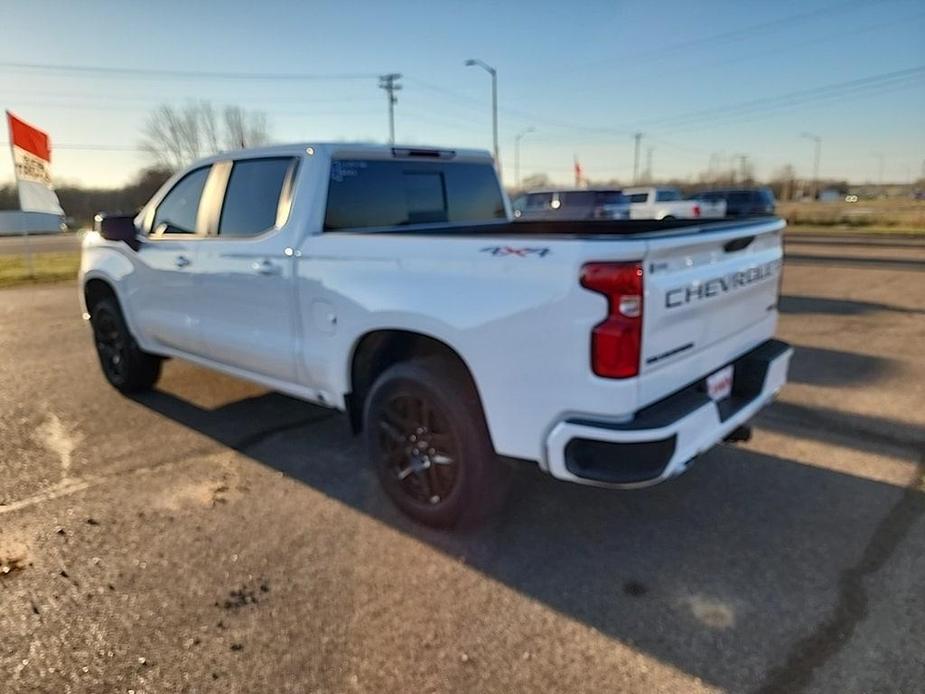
top-left (363, 357), bottom-right (510, 527)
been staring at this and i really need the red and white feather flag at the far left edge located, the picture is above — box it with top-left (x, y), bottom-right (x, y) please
top-left (6, 111), bottom-right (64, 214)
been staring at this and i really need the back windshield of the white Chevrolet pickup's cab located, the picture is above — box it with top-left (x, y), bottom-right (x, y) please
top-left (324, 159), bottom-right (502, 231)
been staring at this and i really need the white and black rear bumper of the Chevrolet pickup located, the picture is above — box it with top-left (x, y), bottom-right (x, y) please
top-left (544, 340), bottom-right (793, 488)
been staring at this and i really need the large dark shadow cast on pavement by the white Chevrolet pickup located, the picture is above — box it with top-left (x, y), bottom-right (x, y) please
top-left (128, 384), bottom-right (925, 691)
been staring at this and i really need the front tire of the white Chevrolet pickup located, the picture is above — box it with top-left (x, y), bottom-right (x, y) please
top-left (90, 298), bottom-right (161, 394)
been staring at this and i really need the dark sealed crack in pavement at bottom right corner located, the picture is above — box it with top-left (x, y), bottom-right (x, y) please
top-left (755, 456), bottom-right (925, 694)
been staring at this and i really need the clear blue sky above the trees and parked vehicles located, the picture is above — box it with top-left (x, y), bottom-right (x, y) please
top-left (0, 0), bottom-right (925, 186)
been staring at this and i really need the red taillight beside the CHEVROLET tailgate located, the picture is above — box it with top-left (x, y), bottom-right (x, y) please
top-left (581, 263), bottom-right (642, 378)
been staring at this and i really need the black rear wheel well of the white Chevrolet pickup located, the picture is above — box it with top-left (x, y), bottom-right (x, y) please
top-left (346, 330), bottom-right (478, 433)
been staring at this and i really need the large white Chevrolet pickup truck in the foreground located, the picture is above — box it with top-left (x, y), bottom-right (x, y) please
top-left (80, 144), bottom-right (791, 526)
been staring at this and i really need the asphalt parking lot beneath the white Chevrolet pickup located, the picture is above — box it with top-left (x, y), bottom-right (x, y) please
top-left (0, 237), bottom-right (925, 692)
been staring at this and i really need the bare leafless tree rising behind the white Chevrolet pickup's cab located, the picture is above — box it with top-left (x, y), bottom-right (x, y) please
top-left (141, 101), bottom-right (270, 169)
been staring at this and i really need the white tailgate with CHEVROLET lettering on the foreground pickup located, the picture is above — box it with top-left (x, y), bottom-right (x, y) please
top-left (640, 220), bottom-right (784, 378)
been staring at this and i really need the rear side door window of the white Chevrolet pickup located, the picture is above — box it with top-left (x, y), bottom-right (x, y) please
top-left (218, 157), bottom-right (294, 237)
